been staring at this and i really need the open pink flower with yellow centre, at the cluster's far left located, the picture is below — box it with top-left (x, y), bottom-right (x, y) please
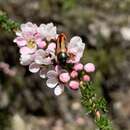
top-left (14, 22), bottom-right (46, 54)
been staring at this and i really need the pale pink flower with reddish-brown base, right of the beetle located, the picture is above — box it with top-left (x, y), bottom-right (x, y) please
top-left (67, 36), bottom-right (85, 63)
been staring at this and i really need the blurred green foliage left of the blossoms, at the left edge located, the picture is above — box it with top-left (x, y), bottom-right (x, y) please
top-left (0, 11), bottom-right (20, 32)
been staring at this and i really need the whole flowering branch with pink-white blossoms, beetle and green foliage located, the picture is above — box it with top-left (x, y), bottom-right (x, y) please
top-left (0, 12), bottom-right (112, 130)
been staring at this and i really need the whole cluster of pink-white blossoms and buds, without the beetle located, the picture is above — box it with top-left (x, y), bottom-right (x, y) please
top-left (14, 22), bottom-right (95, 95)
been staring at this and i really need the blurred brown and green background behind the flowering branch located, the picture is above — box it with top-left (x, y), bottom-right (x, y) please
top-left (0, 0), bottom-right (130, 130)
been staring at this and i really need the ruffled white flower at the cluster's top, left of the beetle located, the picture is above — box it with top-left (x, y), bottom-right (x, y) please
top-left (38, 23), bottom-right (57, 40)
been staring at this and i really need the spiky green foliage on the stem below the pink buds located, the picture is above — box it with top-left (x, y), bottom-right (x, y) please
top-left (80, 83), bottom-right (112, 130)
